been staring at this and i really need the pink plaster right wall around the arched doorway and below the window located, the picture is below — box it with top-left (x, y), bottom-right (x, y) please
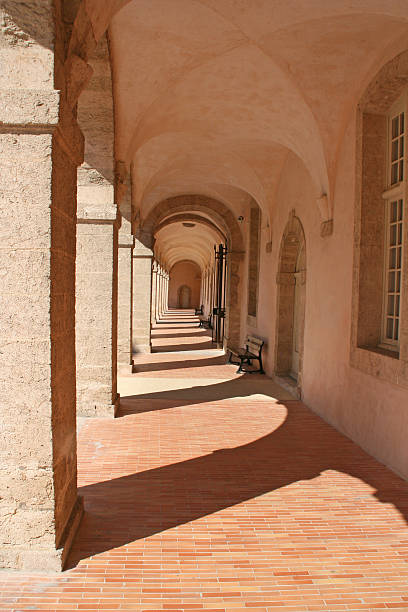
top-left (237, 117), bottom-right (408, 478)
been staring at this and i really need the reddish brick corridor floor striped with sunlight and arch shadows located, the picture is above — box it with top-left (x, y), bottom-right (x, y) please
top-left (0, 311), bottom-right (408, 612)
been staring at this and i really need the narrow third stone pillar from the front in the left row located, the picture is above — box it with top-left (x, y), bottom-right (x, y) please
top-left (118, 228), bottom-right (134, 369)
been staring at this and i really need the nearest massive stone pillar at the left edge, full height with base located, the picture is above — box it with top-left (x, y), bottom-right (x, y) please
top-left (0, 0), bottom-right (83, 572)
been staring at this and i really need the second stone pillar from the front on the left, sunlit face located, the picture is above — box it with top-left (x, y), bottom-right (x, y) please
top-left (76, 203), bottom-right (119, 417)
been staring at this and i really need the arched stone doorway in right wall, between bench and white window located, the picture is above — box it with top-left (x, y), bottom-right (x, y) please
top-left (275, 210), bottom-right (306, 394)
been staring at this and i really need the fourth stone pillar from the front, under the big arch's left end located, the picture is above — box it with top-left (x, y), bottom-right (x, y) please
top-left (132, 239), bottom-right (153, 353)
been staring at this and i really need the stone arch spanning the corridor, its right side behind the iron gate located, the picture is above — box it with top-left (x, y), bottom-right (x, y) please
top-left (140, 195), bottom-right (244, 345)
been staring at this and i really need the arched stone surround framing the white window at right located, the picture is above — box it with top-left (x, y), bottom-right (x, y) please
top-left (350, 51), bottom-right (408, 387)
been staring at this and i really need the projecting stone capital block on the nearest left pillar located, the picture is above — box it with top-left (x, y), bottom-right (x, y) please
top-left (0, 89), bottom-right (60, 132)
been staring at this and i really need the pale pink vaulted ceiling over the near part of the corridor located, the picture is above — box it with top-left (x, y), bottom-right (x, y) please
top-left (105, 0), bottom-right (408, 227)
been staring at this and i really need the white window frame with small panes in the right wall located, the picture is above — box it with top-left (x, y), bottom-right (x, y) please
top-left (379, 91), bottom-right (408, 352)
